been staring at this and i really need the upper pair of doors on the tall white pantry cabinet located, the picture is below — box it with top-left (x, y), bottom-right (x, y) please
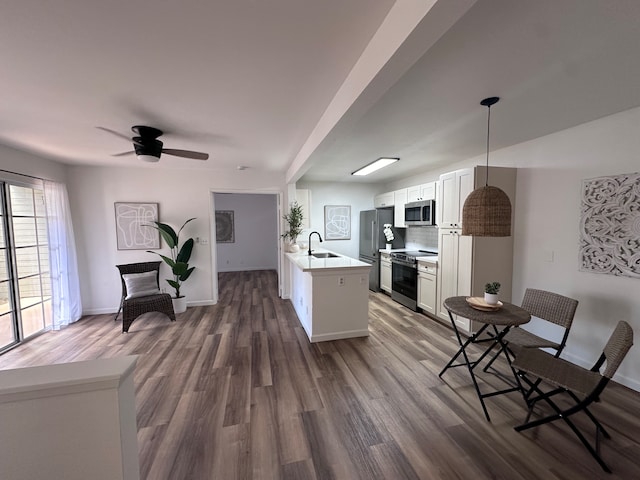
top-left (436, 168), bottom-right (474, 228)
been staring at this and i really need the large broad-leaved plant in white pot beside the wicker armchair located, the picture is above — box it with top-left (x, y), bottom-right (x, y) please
top-left (147, 218), bottom-right (196, 313)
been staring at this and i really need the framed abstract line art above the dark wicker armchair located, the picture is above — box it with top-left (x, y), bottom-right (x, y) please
top-left (114, 202), bottom-right (160, 250)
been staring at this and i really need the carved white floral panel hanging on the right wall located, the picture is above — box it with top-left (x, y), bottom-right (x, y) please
top-left (580, 173), bottom-right (640, 278)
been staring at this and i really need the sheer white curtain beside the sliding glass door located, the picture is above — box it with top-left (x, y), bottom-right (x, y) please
top-left (44, 181), bottom-right (82, 330)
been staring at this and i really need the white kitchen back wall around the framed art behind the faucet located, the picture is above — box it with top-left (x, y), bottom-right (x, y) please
top-left (297, 182), bottom-right (379, 258)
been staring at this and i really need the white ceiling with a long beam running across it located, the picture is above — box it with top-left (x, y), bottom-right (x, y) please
top-left (0, 0), bottom-right (640, 182)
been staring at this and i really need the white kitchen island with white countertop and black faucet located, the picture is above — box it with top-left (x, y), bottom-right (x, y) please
top-left (285, 251), bottom-right (371, 343)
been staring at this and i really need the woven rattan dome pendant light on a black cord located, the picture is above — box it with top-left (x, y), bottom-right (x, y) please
top-left (462, 97), bottom-right (511, 237)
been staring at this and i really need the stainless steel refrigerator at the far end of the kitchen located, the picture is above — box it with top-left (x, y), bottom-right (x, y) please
top-left (358, 208), bottom-right (404, 292)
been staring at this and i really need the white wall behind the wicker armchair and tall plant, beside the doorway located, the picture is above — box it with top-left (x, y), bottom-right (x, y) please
top-left (68, 166), bottom-right (285, 314)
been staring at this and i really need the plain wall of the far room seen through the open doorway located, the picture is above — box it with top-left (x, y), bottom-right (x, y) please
top-left (214, 193), bottom-right (278, 272)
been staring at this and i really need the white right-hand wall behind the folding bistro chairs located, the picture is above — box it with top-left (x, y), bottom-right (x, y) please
top-left (380, 108), bottom-right (640, 391)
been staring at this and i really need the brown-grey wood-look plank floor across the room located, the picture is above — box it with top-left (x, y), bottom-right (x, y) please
top-left (0, 271), bottom-right (640, 480)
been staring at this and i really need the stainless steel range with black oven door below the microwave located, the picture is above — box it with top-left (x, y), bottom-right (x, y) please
top-left (390, 250), bottom-right (438, 311)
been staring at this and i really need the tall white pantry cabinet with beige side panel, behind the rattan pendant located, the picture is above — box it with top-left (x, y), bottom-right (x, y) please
top-left (437, 167), bottom-right (516, 334)
